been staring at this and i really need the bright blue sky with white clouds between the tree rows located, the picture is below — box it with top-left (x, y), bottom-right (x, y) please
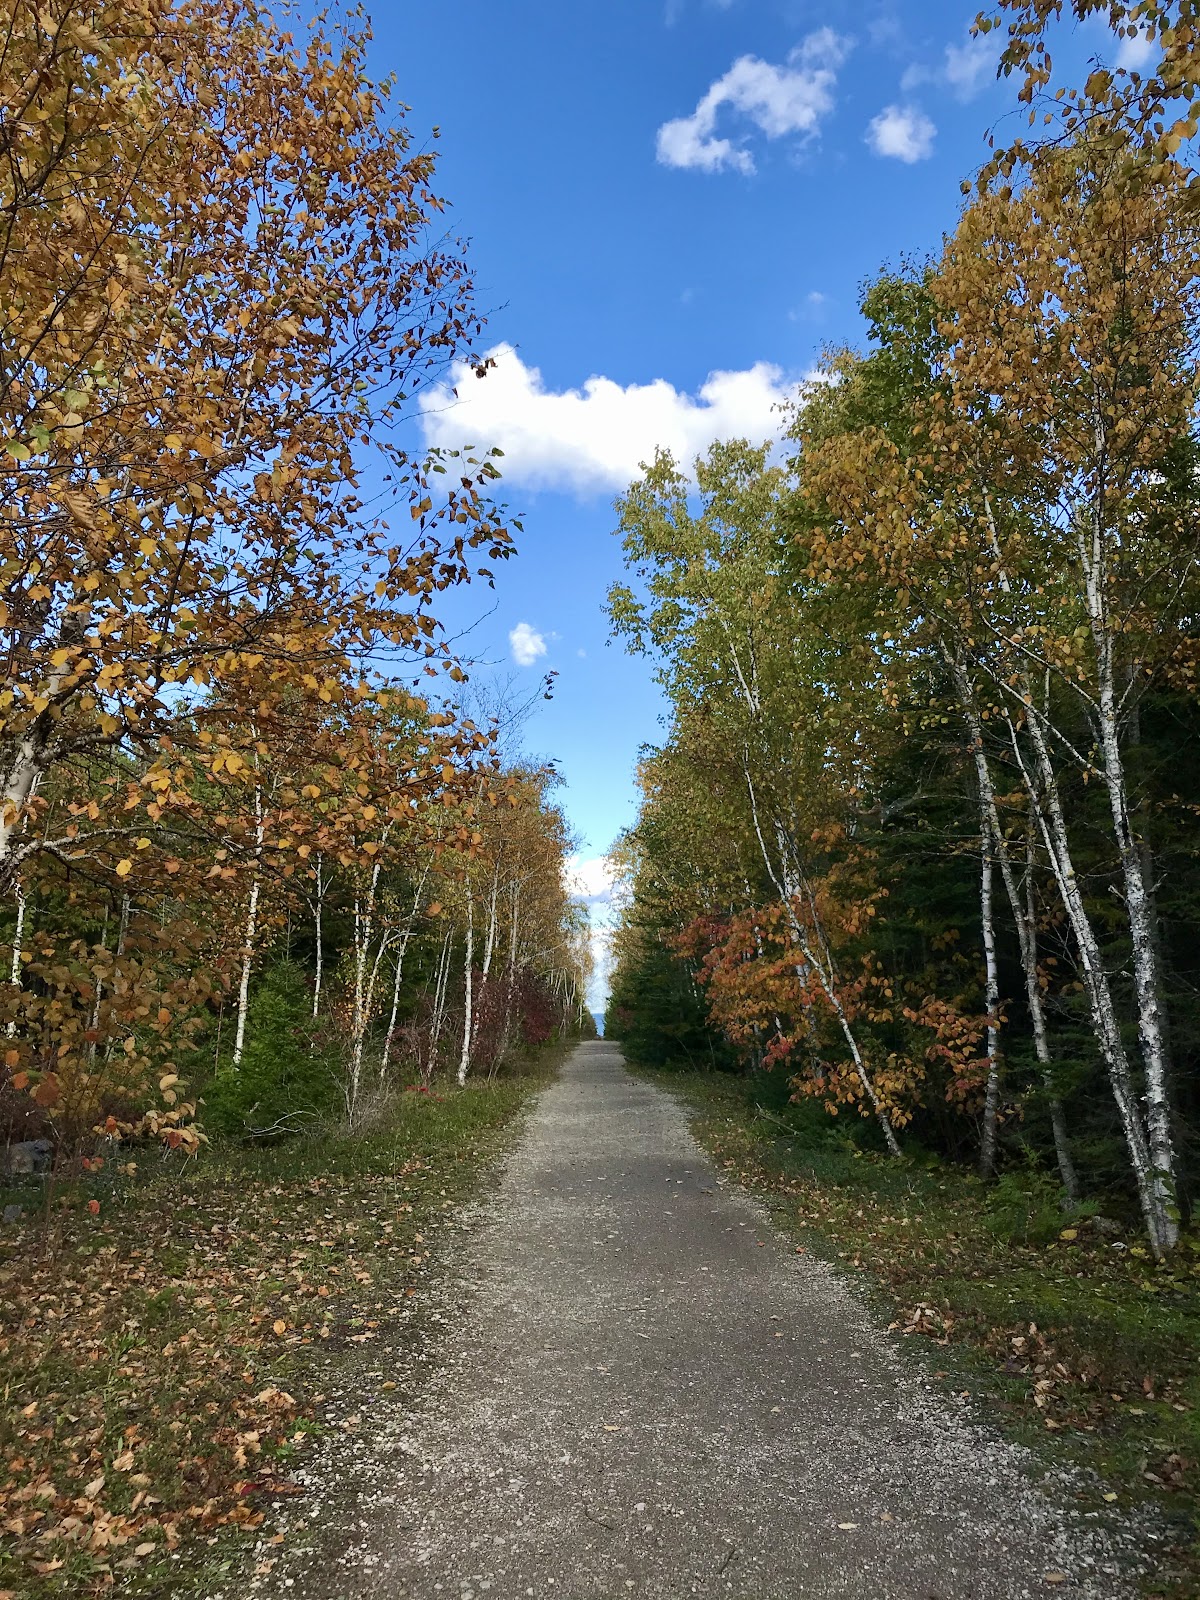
top-left (373, 0), bottom-right (1133, 998)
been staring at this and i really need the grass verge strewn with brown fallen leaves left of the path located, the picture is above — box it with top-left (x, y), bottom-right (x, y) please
top-left (0, 1056), bottom-right (557, 1600)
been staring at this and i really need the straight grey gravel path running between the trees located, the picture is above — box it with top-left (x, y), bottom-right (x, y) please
top-left (265, 1043), bottom-right (1149, 1600)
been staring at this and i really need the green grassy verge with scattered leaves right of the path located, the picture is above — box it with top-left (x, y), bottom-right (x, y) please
top-left (648, 1070), bottom-right (1200, 1600)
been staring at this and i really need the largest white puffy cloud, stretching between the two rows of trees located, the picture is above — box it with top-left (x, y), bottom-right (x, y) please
top-left (421, 344), bottom-right (800, 493)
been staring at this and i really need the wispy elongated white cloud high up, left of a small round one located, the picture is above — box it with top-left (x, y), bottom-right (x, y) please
top-left (658, 27), bottom-right (850, 173)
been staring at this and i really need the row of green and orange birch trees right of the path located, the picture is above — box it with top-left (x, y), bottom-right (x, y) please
top-left (608, 0), bottom-right (1200, 1258)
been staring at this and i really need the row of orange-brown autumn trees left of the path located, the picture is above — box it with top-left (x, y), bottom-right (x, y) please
top-left (0, 0), bottom-right (587, 1160)
